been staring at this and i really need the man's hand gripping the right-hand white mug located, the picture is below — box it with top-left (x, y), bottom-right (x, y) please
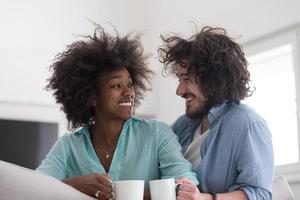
top-left (176, 178), bottom-right (212, 200)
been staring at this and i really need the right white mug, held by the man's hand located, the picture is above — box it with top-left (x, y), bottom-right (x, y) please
top-left (149, 178), bottom-right (179, 200)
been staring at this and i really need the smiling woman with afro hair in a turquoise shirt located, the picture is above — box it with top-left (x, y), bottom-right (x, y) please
top-left (37, 26), bottom-right (198, 200)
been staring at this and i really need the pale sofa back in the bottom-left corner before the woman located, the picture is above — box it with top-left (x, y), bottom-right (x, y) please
top-left (0, 160), bottom-right (94, 200)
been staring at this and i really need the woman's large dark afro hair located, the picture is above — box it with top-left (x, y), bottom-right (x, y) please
top-left (46, 25), bottom-right (153, 128)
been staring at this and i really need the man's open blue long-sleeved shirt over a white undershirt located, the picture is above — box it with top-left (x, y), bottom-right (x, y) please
top-left (172, 102), bottom-right (274, 200)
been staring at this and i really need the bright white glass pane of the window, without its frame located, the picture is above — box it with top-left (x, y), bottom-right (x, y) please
top-left (246, 44), bottom-right (299, 165)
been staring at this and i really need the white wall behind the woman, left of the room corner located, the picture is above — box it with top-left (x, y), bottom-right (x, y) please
top-left (0, 0), bottom-right (150, 133)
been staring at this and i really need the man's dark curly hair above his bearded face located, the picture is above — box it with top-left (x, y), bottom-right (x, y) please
top-left (158, 26), bottom-right (253, 107)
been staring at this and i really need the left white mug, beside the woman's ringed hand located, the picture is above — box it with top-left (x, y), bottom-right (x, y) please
top-left (113, 180), bottom-right (144, 200)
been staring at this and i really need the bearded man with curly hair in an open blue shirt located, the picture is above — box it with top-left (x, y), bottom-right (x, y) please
top-left (159, 27), bottom-right (274, 200)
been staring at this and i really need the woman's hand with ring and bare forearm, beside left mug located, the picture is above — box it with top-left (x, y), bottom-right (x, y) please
top-left (63, 173), bottom-right (114, 200)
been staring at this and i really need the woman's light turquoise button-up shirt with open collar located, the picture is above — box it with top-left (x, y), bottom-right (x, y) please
top-left (36, 117), bottom-right (198, 188)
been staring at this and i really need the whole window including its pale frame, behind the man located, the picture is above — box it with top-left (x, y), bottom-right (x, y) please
top-left (244, 28), bottom-right (300, 177)
